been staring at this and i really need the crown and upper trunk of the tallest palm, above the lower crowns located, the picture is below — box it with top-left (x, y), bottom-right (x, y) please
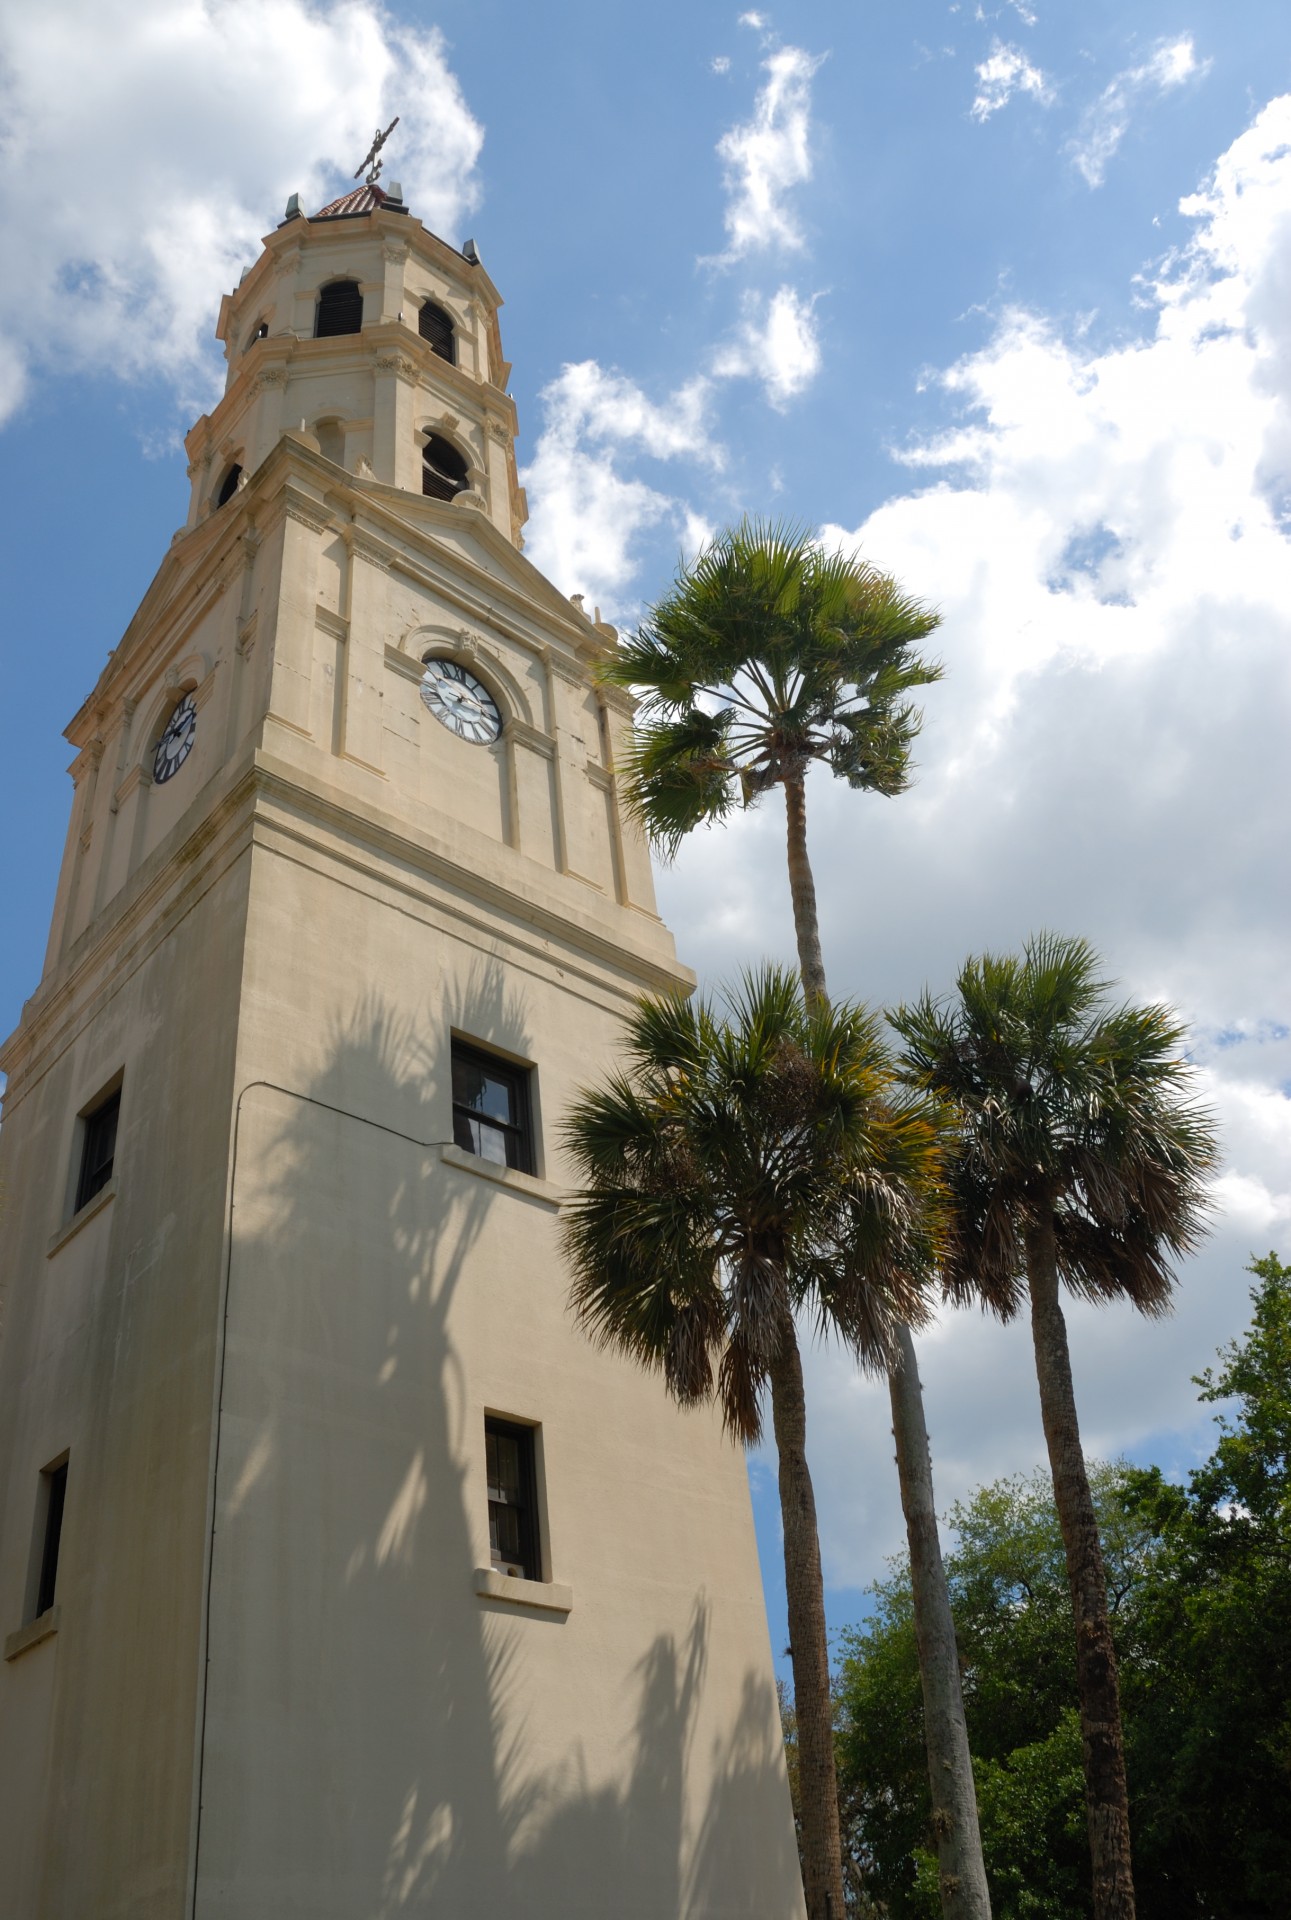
top-left (601, 520), bottom-right (941, 998)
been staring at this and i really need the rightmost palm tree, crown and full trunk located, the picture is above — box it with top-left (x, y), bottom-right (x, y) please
top-left (891, 935), bottom-right (1216, 1920)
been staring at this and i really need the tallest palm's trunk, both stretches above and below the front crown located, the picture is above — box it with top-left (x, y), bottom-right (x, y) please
top-left (772, 774), bottom-right (991, 1920)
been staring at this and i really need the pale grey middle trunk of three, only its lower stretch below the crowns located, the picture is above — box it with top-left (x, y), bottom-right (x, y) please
top-left (888, 1327), bottom-right (991, 1920)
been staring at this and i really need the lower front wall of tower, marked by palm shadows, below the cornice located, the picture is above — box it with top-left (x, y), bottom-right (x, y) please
top-left (196, 808), bottom-right (801, 1920)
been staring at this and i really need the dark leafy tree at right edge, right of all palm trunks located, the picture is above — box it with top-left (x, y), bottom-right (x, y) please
top-left (1126, 1254), bottom-right (1291, 1920)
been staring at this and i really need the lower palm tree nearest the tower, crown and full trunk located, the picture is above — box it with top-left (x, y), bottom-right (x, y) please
top-left (563, 970), bottom-right (941, 1920)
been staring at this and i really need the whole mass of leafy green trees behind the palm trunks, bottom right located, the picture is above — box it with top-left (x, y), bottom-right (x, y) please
top-left (838, 1254), bottom-right (1291, 1920)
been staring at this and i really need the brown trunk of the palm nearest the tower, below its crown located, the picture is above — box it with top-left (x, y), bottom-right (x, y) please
top-left (770, 1311), bottom-right (843, 1920)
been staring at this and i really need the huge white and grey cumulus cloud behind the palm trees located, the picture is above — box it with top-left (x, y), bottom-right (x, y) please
top-left (661, 96), bottom-right (1291, 1584)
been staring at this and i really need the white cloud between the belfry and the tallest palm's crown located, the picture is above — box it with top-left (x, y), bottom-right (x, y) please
top-left (521, 361), bottom-right (724, 614)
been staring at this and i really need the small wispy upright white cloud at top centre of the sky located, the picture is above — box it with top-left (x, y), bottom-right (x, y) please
top-left (717, 42), bottom-right (824, 265)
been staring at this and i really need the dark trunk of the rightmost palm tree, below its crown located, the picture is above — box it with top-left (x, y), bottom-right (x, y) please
top-left (1026, 1215), bottom-right (1133, 1920)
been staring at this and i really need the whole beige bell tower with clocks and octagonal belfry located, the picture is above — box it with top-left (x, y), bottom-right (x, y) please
top-left (0, 182), bottom-right (801, 1920)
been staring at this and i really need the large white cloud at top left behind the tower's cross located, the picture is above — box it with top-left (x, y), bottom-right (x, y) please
top-left (0, 0), bottom-right (482, 420)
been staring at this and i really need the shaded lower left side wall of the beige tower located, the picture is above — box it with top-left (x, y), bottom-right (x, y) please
top-left (0, 814), bottom-right (248, 1920)
